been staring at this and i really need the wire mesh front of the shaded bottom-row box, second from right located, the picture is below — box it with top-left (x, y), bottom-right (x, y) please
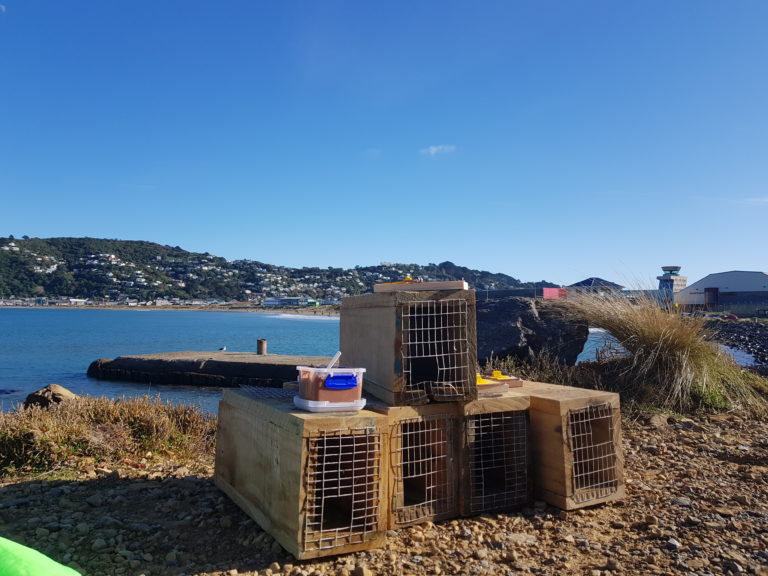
top-left (464, 410), bottom-right (530, 514)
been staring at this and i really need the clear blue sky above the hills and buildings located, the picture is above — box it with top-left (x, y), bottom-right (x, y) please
top-left (0, 0), bottom-right (768, 287)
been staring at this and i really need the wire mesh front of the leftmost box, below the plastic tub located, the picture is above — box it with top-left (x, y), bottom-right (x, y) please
top-left (304, 429), bottom-right (381, 550)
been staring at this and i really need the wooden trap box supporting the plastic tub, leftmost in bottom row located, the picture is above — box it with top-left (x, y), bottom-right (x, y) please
top-left (214, 390), bottom-right (388, 560)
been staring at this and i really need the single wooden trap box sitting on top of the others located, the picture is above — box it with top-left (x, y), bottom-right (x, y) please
top-left (340, 290), bottom-right (477, 406)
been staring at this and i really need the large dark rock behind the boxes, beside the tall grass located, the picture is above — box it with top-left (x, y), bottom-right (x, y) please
top-left (477, 297), bottom-right (589, 365)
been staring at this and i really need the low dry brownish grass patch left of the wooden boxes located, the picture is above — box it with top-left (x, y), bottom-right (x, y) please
top-left (0, 396), bottom-right (216, 476)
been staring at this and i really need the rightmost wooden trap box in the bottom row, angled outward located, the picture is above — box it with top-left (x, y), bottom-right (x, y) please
top-left (507, 381), bottom-right (625, 510)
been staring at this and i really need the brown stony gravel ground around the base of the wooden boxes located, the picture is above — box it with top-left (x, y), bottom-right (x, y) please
top-left (0, 415), bottom-right (768, 576)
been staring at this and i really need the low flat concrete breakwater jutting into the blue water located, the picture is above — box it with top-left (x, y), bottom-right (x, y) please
top-left (88, 351), bottom-right (331, 388)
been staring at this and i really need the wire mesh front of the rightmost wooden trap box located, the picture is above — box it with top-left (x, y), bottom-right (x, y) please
top-left (568, 403), bottom-right (618, 503)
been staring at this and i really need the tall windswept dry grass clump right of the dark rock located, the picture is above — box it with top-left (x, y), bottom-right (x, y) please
top-left (567, 295), bottom-right (768, 416)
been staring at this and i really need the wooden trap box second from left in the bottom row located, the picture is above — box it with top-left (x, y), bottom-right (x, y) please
top-left (370, 402), bottom-right (461, 530)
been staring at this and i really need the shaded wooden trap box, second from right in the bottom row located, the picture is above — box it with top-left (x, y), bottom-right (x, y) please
top-left (460, 394), bottom-right (533, 516)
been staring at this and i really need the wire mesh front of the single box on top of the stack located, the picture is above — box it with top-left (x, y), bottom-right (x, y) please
top-left (401, 299), bottom-right (475, 401)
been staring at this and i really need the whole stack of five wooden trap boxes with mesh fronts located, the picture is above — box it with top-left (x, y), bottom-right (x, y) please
top-left (215, 283), bottom-right (624, 559)
